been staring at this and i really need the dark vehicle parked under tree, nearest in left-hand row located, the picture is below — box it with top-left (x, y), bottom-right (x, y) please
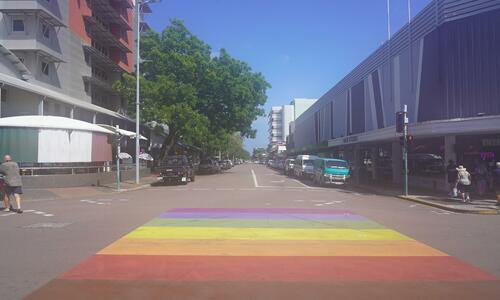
top-left (158, 155), bottom-right (195, 184)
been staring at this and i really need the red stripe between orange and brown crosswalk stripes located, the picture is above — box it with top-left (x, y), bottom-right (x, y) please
top-left (62, 255), bottom-right (495, 282)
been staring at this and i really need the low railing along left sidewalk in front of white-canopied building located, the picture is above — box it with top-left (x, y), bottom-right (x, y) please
top-left (19, 161), bottom-right (148, 176)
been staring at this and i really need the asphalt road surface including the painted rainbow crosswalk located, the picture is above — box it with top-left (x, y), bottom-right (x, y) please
top-left (0, 165), bottom-right (500, 300)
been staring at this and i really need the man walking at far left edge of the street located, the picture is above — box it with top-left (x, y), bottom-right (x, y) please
top-left (0, 155), bottom-right (23, 214)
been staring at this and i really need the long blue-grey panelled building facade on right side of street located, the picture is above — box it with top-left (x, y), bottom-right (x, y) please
top-left (294, 0), bottom-right (500, 189)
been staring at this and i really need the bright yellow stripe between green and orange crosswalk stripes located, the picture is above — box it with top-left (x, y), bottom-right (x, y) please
top-left (126, 226), bottom-right (410, 241)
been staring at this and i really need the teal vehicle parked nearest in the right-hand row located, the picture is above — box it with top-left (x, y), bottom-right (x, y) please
top-left (313, 158), bottom-right (351, 185)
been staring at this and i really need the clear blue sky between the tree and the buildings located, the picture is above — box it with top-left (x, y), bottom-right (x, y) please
top-left (147, 0), bottom-right (430, 151)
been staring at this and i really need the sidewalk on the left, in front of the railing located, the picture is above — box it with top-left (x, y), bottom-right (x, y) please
top-left (23, 175), bottom-right (157, 201)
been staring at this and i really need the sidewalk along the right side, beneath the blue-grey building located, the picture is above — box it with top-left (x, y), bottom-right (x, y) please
top-left (354, 184), bottom-right (500, 215)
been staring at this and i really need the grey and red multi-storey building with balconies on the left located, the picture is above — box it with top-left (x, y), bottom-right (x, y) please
top-left (0, 0), bottom-right (149, 129)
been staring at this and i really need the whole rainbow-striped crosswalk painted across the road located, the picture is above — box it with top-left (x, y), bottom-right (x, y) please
top-left (28, 208), bottom-right (500, 300)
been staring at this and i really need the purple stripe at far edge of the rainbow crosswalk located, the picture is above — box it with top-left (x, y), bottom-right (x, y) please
top-left (168, 208), bottom-right (352, 214)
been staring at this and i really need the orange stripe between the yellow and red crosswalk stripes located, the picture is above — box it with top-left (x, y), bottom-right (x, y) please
top-left (98, 238), bottom-right (447, 256)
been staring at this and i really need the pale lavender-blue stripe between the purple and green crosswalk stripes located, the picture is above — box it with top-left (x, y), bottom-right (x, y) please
top-left (160, 213), bottom-right (367, 221)
